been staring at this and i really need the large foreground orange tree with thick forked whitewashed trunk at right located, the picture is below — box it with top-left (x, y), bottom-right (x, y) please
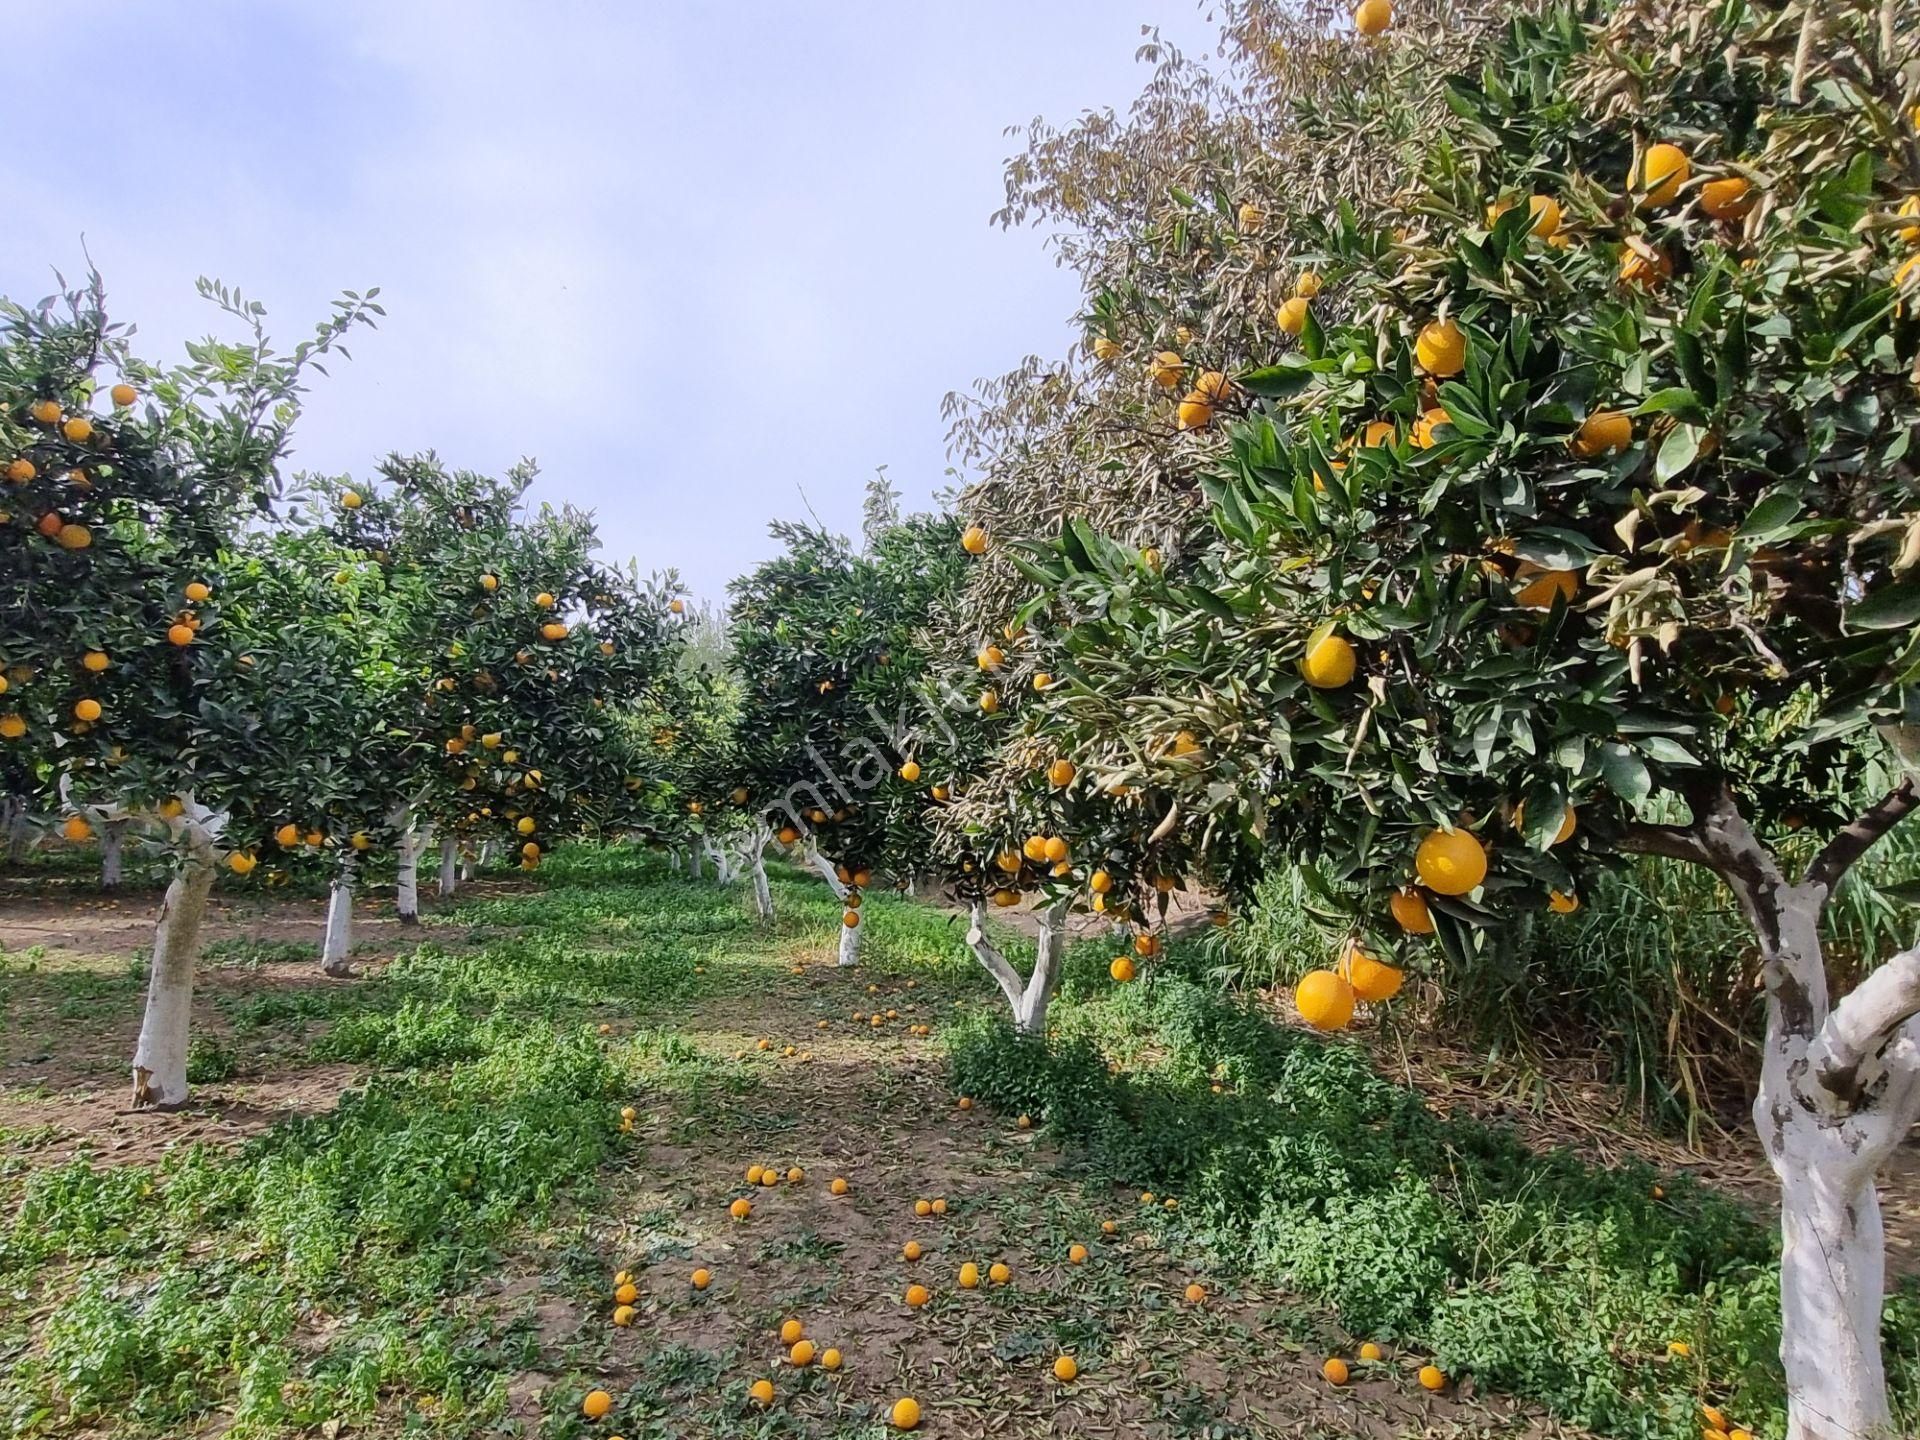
top-left (990, 4), bottom-right (1920, 1440)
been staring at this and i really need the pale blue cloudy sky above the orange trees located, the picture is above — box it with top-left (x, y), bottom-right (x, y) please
top-left (0, 0), bottom-right (1213, 603)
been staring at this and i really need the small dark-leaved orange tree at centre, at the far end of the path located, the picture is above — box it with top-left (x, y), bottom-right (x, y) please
top-left (728, 516), bottom-right (966, 964)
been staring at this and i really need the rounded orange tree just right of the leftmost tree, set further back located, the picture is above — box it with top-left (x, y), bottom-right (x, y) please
top-left (323, 455), bottom-right (680, 908)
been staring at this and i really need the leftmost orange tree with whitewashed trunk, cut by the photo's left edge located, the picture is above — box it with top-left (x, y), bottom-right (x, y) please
top-left (0, 276), bottom-right (378, 1104)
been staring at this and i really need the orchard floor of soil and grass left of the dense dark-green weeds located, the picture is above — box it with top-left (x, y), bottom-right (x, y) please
top-left (0, 844), bottom-right (1620, 1440)
